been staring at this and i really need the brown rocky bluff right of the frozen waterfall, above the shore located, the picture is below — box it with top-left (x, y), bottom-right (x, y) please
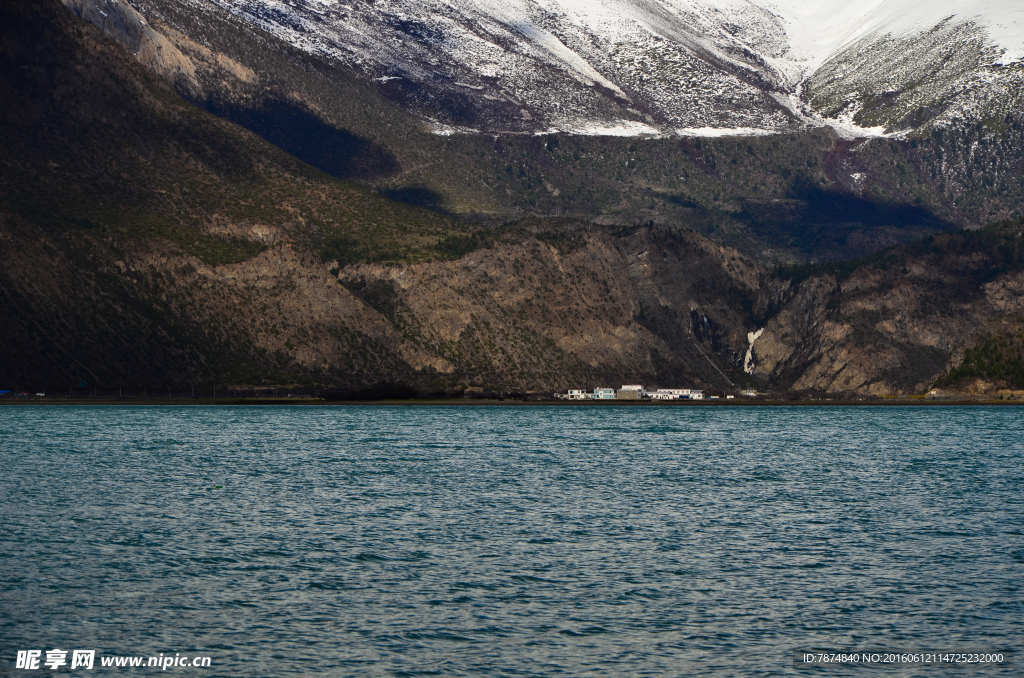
top-left (752, 222), bottom-right (1024, 395)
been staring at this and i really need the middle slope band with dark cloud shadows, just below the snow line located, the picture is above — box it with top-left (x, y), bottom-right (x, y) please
top-left (70, 0), bottom-right (1024, 261)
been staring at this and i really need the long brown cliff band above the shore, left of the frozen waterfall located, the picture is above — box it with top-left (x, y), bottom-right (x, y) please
top-left (0, 209), bottom-right (763, 391)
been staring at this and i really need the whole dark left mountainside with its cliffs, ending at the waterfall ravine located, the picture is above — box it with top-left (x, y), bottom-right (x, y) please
top-left (0, 3), bottom-right (770, 390)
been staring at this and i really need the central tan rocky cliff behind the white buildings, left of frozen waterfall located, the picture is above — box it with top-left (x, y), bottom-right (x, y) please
top-left (339, 226), bottom-right (762, 390)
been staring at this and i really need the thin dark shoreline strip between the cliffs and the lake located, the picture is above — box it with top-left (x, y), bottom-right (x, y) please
top-left (0, 396), bottom-right (1024, 408)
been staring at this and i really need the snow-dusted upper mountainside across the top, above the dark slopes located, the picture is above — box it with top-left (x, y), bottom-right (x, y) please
top-left (195, 0), bottom-right (1024, 135)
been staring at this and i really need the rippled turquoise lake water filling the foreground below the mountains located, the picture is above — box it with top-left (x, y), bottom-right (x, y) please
top-left (0, 407), bottom-right (1024, 677)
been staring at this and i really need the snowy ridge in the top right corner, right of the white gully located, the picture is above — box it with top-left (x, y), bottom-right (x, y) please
top-left (807, 0), bottom-right (1024, 131)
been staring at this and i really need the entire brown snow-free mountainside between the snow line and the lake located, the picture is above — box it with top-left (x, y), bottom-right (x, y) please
top-left (6, 2), bottom-right (1024, 394)
